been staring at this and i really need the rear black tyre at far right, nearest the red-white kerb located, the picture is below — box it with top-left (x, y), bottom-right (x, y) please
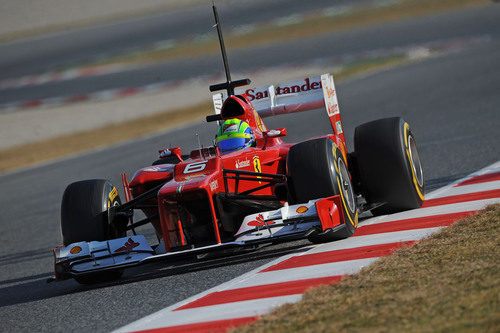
top-left (354, 117), bottom-right (425, 215)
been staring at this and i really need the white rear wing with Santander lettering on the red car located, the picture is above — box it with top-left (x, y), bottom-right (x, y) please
top-left (212, 74), bottom-right (344, 139)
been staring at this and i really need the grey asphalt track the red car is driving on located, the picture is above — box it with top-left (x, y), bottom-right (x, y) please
top-left (0, 7), bottom-right (500, 332)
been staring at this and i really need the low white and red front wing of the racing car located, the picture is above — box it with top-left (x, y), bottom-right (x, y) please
top-left (53, 196), bottom-right (345, 280)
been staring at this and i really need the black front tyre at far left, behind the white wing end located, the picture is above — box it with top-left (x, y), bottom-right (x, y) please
top-left (61, 179), bottom-right (126, 284)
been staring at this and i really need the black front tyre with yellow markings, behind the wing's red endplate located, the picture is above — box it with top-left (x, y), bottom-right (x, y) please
top-left (287, 138), bottom-right (358, 243)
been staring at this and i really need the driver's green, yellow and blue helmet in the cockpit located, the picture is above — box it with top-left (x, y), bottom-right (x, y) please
top-left (216, 119), bottom-right (255, 153)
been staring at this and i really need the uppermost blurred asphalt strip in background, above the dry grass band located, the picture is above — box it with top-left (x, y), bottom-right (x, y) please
top-left (0, 0), bottom-right (362, 79)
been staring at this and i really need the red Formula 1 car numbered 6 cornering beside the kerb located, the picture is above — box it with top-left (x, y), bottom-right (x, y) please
top-left (50, 5), bottom-right (424, 283)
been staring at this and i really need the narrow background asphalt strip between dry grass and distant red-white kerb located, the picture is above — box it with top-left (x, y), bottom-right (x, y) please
top-left (0, 5), bottom-right (500, 104)
